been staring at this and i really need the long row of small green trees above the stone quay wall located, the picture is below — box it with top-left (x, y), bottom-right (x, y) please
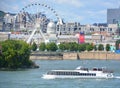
top-left (32, 42), bottom-right (110, 52)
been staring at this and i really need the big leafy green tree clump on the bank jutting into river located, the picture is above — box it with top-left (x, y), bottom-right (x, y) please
top-left (0, 40), bottom-right (33, 69)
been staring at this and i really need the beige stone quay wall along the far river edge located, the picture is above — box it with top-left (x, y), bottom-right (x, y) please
top-left (30, 52), bottom-right (120, 60)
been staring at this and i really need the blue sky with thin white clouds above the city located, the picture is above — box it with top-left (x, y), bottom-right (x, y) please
top-left (0, 0), bottom-right (120, 24)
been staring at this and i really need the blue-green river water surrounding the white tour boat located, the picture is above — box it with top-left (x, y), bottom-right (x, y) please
top-left (0, 60), bottom-right (120, 88)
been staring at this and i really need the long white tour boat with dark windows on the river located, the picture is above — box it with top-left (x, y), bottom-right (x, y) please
top-left (43, 66), bottom-right (114, 79)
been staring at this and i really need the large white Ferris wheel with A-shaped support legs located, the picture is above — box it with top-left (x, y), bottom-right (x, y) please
top-left (18, 3), bottom-right (60, 43)
